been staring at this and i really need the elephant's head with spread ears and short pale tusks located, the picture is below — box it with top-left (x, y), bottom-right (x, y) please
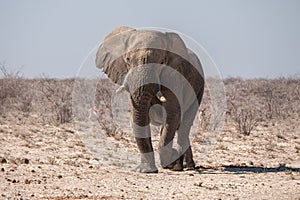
top-left (96, 27), bottom-right (196, 102)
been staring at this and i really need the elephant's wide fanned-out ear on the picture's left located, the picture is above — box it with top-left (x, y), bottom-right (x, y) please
top-left (96, 27), bottom-right (135, 84)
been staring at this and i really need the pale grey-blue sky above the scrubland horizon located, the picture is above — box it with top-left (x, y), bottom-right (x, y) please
top-left (0, 0), bottom-right (300, 78)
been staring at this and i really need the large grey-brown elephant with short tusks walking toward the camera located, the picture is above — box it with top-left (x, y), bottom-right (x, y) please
top-left (95, 27), bottom-right (204, 173)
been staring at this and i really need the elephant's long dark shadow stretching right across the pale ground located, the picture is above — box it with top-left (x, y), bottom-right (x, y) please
top-left (196, 165), bottom-right (300, 174)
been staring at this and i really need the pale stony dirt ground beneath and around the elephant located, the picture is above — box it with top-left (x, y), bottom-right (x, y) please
top-left (0, 113), bottom-right (300, 199)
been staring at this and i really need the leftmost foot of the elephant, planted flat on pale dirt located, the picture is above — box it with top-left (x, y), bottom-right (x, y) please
top-left (136, 152), bottom-right (158, 173)
